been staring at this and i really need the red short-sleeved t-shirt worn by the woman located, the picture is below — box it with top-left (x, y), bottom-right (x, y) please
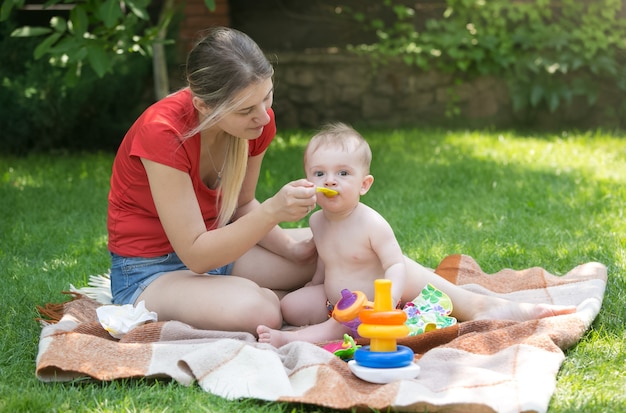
top-left (107, 88), bottom-right (276, 257)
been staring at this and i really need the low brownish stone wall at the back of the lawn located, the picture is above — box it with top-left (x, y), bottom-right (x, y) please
top-left (268, 51), bottom-right (625, 129)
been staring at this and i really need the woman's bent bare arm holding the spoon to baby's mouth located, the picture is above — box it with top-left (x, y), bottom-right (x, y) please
top-left (141, 158), bottom-right (315, 273)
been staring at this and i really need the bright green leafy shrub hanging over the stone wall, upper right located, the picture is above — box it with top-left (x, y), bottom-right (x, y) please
top-left (344, 0), bottom-right (626, 116)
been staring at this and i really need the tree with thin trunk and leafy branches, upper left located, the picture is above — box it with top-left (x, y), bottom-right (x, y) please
top-left (0, 0), bottom-right (215, 99)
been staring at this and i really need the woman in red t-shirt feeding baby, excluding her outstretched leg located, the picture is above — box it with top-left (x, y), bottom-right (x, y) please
top-left (107, 28), bottom-right (316, 333)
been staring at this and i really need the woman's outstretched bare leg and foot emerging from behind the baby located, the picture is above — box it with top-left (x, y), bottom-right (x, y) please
top-left (402, 257), bottom-right (576, 321)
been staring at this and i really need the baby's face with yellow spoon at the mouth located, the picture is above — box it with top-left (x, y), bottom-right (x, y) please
top-left (305, 147), bottom-right (367, 208)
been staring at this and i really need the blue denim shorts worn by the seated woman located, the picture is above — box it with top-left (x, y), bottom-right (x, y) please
top-left (110, 252), bottom-right (235, 305)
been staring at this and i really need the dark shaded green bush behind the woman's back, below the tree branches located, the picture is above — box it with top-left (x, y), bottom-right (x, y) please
top-left (0, 23), bottom-right (150, 154)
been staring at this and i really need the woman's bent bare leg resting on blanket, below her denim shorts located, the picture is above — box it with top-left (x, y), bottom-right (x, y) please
top-left (137, 271), bottom-right (282, 334)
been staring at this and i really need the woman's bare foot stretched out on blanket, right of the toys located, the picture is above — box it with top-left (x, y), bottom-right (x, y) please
top-left (474, 300), bottom-right (576, 321)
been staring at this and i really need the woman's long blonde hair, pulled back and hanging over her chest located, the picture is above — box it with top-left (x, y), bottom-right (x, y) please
top-left (185, 27), bottom-right (274, 227)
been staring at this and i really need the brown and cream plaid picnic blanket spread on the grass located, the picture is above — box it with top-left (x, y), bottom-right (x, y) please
top-left (36, 255), bottom-right (606, 412)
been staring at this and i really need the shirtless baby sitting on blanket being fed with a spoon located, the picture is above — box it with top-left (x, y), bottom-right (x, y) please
top-left (257, 123), bottom-right (406, 347)
